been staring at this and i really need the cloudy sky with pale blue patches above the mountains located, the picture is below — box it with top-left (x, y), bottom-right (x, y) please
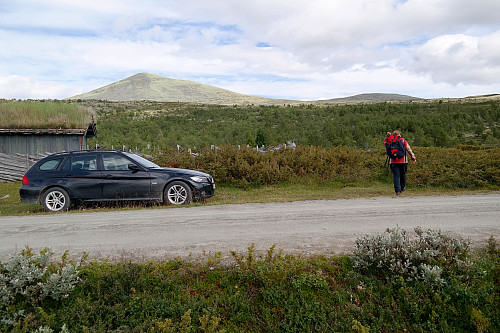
top-left (0, 0), bottom-right (500, 100)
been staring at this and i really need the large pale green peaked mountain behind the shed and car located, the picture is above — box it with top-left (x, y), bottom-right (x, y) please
top-left (69, 73), bottom-right (286, 105)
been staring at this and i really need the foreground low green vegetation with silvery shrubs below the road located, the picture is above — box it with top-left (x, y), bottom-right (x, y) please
top-left (0, 228), bottom-right (500, 332)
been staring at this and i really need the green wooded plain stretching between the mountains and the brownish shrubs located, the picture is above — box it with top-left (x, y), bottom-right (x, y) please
top-left (80, 100), bottom-right (500, 149)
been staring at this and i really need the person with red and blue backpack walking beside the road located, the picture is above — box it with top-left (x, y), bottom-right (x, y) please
top-left (384, 131), bottom-right (417, 196)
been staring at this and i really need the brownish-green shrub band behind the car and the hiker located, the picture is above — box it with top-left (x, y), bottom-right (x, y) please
top-left (155, 145), bottom-right (500, 189)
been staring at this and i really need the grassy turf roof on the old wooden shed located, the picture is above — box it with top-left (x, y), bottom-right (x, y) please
top-left (0, 100), bottom-right (93, 129)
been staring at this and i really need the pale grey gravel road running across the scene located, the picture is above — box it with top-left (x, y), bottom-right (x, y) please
top-left (0, 193), bottom-right (500, 260)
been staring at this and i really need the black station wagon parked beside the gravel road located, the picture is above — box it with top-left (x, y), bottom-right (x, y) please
top-left (19, 150), bottom-right (215, 212)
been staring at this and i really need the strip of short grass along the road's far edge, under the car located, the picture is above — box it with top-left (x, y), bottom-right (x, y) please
top-left (0, 179), bottom-right (499, 216)
